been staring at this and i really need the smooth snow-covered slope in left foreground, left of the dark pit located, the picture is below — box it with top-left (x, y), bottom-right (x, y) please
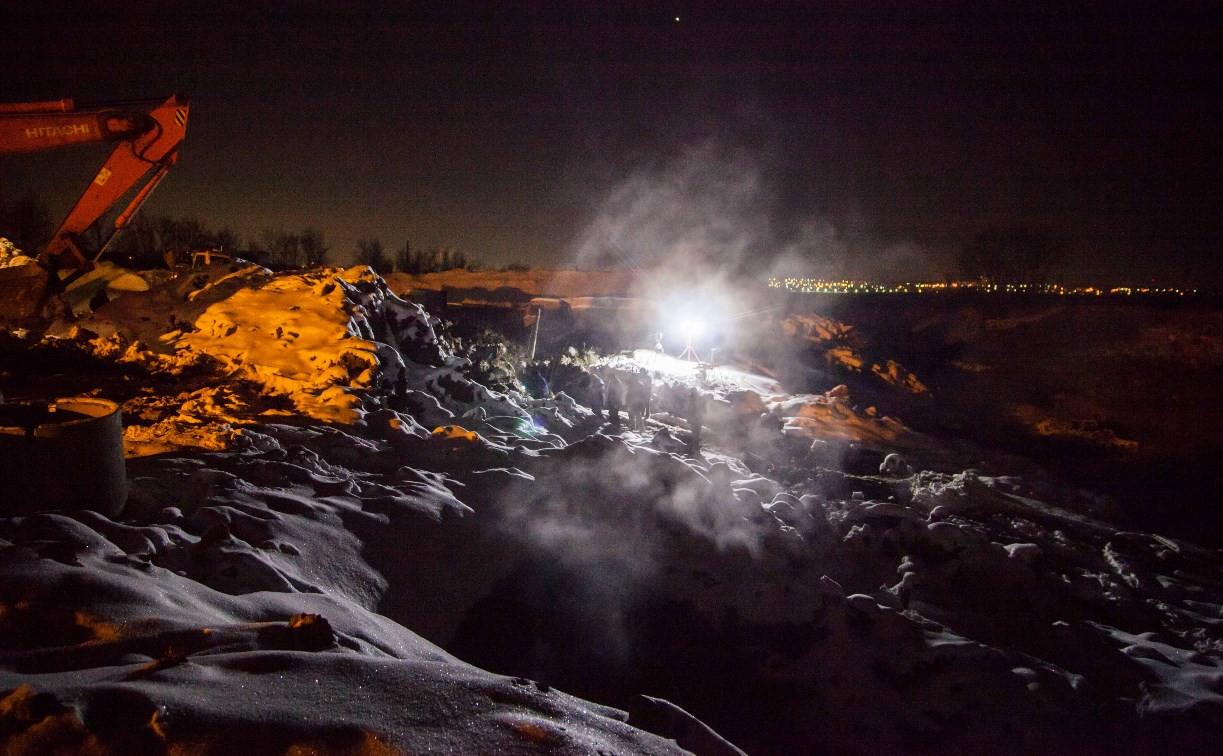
top-left (0, 426), bottom-right (680, 754)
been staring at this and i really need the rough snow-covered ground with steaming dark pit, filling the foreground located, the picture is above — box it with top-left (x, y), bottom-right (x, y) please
top-left (0, 264), bottom-right (1223, 754)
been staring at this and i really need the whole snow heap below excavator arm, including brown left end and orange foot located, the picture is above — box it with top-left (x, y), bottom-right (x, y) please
top-left (49, 261), bottom-right (530, 456)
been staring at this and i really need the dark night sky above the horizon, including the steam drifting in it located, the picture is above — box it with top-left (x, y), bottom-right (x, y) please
top-left (0, 2), bottom-right (1223, 287)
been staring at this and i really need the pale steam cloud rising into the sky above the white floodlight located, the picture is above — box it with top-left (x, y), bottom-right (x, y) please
top-left (572, 142), bottom-right (943, 287)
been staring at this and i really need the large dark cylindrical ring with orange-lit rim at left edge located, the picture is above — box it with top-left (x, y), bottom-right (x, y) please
top-left (0, 396), bottom-right (127, 516)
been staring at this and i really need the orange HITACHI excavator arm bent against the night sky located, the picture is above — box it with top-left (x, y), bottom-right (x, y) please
top-left (0, 94), bottom-right (190, 273)
